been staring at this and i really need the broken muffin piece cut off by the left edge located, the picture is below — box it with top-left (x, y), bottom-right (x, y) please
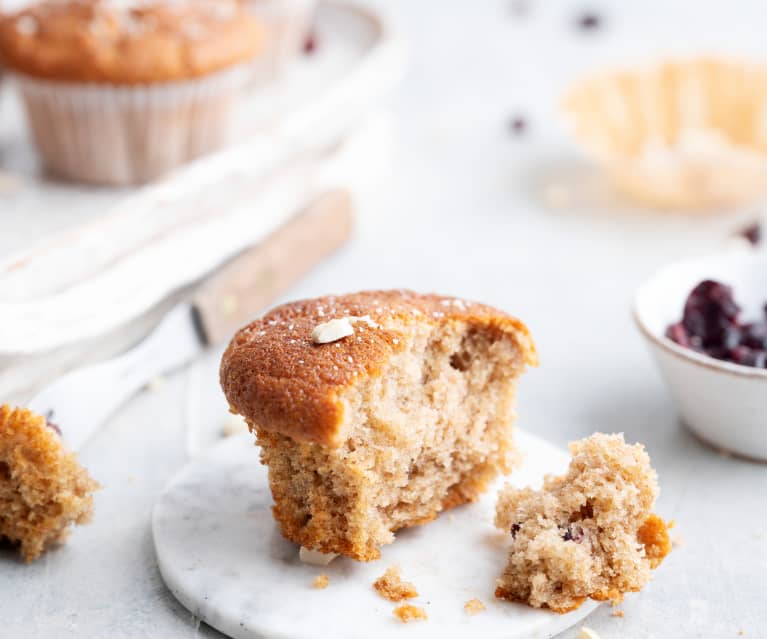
top-left (0, 405), bottom-right (98, 561)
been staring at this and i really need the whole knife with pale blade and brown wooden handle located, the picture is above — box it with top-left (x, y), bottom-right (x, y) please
top-left (29, 190), bottom-right (352, 450)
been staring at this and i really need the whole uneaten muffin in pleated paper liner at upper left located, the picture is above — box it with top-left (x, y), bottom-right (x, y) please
top-left (0, 0), bottom-right (266, 185)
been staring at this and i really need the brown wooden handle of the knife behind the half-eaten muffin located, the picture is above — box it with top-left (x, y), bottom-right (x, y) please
top-left (192, 190), bottom-right (352, 344)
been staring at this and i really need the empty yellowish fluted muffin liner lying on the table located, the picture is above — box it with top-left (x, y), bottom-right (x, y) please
top-left (564, 59), bottom-right (767, 211)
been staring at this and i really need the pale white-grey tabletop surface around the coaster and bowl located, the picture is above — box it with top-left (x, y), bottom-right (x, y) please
top-left (0, 0), bottom-right (767, 639)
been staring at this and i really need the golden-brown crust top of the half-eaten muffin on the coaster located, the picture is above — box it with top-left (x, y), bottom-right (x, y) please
top-left (220, 290), bottom-right (537, 446)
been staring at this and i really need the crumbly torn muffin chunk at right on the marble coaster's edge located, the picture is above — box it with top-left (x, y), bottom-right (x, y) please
top-left (495, 433), bottom-right (671, 613)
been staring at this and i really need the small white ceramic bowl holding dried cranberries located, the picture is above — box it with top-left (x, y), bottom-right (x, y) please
top-left (634, 251), bottom-right (767, 461)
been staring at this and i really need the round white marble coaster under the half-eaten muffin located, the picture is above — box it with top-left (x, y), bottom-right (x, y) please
top-left (152, 432), bottom-right (597, 639)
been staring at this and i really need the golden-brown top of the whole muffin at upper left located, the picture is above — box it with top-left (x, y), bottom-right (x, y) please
top-left (0, 0), bottom-right (266, 85)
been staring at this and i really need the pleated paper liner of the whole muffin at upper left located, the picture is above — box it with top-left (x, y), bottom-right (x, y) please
top-left (13, 64), bottom-right (253, 186)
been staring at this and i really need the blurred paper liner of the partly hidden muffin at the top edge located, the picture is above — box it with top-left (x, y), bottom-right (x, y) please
top-left (247, 0), bottom-right (317, 77)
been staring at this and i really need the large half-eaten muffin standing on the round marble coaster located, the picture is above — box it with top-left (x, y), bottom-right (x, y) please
top-left (221, 291), bottom-right (537, 561)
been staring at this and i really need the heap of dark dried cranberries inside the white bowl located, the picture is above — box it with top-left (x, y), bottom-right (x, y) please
top-left (666, 280), bottom-right (767, 369)
